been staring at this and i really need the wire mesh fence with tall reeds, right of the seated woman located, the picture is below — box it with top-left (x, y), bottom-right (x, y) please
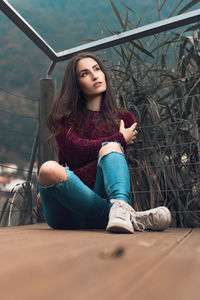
top-left (108, 29), bottom-right (200, 227)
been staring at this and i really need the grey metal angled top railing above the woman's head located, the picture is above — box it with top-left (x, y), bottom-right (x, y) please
top-left (0, 0), bottom-right (200, 76)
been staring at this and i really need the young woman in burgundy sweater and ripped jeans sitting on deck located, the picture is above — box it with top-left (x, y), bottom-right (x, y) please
top-left (39, 53), bottom-right (171, 233)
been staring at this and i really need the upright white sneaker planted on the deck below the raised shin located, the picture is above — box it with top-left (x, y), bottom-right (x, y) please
top-left (106, 199), bottom-right (134, 233)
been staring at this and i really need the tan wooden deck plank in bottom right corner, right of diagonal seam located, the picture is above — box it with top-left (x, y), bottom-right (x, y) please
top-left (129, 229), bottom-right (200, 300)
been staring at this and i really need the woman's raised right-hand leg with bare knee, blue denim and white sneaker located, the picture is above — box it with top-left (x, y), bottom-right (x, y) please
top-left (95, 142), bottom-right (134, 233)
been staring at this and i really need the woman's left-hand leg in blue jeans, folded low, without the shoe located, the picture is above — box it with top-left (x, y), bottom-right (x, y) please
top-left (39, 161), bottom-right (111, 229)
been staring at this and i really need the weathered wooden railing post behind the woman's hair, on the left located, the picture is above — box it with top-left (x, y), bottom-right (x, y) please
top-left (38, 78), bottom-right (56, 170)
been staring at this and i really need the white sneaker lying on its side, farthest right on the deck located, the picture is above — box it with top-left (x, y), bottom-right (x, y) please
top-left (134, 206), bottom-right (171, 231)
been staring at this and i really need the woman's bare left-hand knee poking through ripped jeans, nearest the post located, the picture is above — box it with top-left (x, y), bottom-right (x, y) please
top-left (38, 161), bottom-right (67, 186)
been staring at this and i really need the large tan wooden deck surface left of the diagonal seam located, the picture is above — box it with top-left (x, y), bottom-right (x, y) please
top-left (0, 224), bottom-right (195, 300)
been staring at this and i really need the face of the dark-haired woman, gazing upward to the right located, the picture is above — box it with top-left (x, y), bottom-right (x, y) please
top-left (76, 57), bottom-right (106, 98)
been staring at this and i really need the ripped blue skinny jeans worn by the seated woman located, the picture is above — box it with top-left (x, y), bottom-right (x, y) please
top-left (39, 143), bottom-right (131, 229)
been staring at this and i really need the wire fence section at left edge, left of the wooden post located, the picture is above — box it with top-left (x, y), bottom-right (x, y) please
top-left (0, 88), bottom-right (38, 226)
